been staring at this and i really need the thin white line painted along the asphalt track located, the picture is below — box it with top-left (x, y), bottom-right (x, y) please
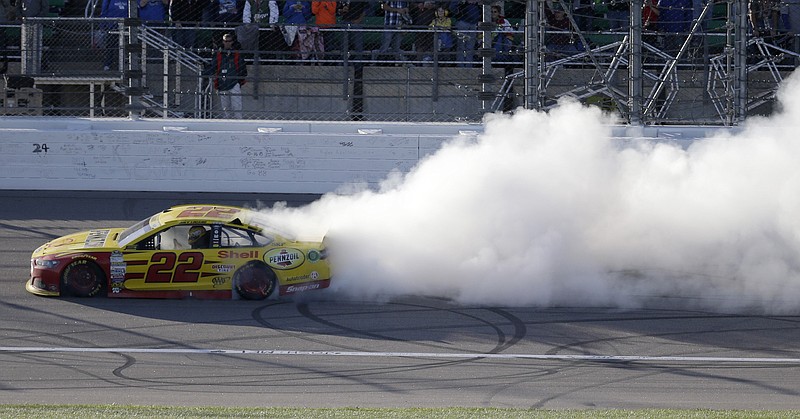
top-left (0, 346), bottom-right (800, 364)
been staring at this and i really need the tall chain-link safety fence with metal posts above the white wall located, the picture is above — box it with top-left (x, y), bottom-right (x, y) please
top-left (0, 0), bottom-right (800, 124)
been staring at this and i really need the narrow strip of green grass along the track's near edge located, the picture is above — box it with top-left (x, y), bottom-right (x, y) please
top-left (0, 405), bottom-right (800, 419)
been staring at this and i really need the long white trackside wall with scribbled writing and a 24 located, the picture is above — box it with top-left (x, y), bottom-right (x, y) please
top-left (0, 118), bottom-right (728, 193)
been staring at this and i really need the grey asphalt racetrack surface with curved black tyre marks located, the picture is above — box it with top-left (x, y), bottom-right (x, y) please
top-left (0, 191), bottom-right (800, 409)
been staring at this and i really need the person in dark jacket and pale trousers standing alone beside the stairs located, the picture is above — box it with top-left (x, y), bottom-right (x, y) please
top-left (209, 33), bottom-right (247, 119)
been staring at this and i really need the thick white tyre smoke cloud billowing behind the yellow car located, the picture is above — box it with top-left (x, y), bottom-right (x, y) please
top-left (264, 74), bottom-right (800, 314)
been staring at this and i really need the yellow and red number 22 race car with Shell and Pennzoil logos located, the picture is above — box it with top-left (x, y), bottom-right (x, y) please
top-left (26, 205), bottom-right (331, 300)
